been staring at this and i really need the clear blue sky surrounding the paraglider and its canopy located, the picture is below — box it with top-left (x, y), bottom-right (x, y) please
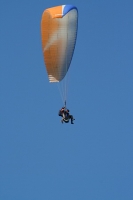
top-left (0, 0), bottom-right (133, 200)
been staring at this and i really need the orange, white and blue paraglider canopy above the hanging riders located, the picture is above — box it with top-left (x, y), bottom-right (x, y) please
top-left (41, 5), bottom-right (78, 104)
